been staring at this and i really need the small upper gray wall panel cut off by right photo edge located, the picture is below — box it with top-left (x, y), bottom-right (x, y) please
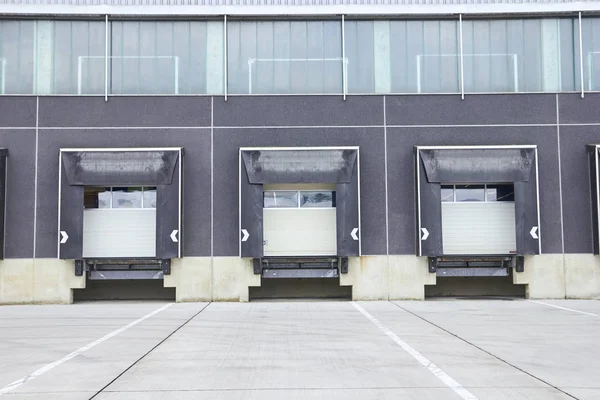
top-left (558, 93), bottom-right (600, 124)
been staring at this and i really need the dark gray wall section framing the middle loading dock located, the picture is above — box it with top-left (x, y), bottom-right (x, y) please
top-left (214, 96), bottom-right (386, 256)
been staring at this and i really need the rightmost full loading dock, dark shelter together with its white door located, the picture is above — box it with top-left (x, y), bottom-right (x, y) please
top-left (415, 146), bottom-right (541, 257)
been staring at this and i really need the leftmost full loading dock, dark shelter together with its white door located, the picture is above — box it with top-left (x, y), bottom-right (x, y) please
top-left (58, 148), bottom-right (183, 259)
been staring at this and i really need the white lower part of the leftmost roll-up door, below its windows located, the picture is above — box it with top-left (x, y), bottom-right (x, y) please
top-left (83, 209), bottom-right (156, 258)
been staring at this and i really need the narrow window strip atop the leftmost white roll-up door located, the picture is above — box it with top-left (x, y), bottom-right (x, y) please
top-left (83, 187), bottom-right (156, 209)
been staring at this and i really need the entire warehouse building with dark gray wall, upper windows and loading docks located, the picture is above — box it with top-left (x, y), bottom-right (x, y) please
top-left (0, 0), bottom-right (600, 303)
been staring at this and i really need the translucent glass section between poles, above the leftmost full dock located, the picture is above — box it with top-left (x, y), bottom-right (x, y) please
top-left (109, 21), bottom-right (223, 94)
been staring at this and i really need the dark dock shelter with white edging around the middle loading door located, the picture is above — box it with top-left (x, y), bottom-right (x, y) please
top-left (239, 147), bottom-right (360, 258)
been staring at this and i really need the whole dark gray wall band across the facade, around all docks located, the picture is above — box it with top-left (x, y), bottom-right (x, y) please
top-left (0, 94), bottom-right (600, 258)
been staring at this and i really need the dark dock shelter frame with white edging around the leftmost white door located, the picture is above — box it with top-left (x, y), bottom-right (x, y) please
top-left (58, 148), bottom-right (183, 273)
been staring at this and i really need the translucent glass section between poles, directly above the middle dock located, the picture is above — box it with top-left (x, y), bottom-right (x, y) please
top-left (227, 21), bottom-right (343, 94)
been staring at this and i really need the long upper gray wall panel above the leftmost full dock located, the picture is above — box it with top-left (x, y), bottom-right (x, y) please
top-left (39, 96), bottom-right (210, 127)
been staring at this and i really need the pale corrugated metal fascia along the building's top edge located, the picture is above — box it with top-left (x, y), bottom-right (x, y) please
top-left (0, 0), bottom-right (600, 17)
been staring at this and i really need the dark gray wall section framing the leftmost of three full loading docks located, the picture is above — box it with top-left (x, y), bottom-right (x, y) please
top-left (36, 97), bottom-right (211, 257)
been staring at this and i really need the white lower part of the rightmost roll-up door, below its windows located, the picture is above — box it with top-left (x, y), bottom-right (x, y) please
top-left (442, 201), bottom-right (517, 255)
